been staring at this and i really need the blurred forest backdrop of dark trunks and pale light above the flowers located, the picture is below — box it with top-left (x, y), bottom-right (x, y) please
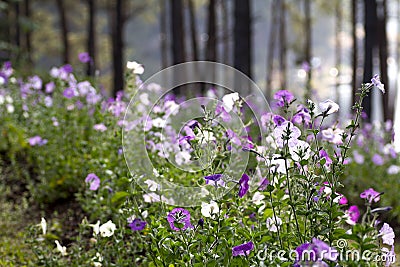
top-left (0, 0), bottom-right (400, 123)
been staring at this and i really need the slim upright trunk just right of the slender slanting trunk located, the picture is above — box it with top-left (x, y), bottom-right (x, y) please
top-left (279, 0), bottom-right (287, 89)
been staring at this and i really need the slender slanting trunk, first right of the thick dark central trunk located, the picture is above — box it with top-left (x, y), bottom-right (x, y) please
top-left (265, 0), bottom-right (278, 101)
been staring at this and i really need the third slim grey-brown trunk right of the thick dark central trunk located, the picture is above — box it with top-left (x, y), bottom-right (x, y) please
top-left (304, 0), bottom-right (312, 99)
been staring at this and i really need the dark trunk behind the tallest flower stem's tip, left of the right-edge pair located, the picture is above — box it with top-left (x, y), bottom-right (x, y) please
top-left (363, 0), bottom-right (377, 122)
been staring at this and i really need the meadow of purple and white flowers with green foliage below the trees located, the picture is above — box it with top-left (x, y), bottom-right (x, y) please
top-left (0, 55), bottom-right (400, 266)
